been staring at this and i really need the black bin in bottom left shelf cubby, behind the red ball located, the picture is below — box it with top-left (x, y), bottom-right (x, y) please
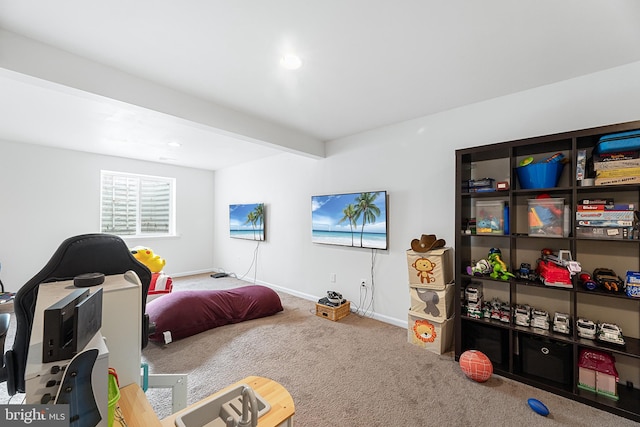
top-left (462, 322), bottom-right (509, 365)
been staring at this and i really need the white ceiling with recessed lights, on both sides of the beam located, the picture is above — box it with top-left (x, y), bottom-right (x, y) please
top-left (0, 0), bottom-right (640, 170)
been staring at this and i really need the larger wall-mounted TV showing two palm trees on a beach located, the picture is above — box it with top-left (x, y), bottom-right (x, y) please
top-left (311, 191), bottom-right (388, 249)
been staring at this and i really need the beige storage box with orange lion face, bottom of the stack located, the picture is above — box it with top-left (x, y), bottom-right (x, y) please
top-left (407, 313), bottom-right (454, 354)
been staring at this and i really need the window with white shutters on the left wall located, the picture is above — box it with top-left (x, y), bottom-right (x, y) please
top-left (100, 171), bottom-right (175, 236)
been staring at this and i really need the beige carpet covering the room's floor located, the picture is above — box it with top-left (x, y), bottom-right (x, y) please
top-left (143, 275), bottom-right (638, 427)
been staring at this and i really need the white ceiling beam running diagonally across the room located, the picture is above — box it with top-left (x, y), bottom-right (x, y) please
top-left (0, 29), bottom-right (325, 158)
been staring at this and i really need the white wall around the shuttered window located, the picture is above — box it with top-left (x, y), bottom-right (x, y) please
top-left (0, 141), bottom-right (214, 291)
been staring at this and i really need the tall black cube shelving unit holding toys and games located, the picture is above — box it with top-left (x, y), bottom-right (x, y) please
top-left (455, 121), bottom-right (640, 422)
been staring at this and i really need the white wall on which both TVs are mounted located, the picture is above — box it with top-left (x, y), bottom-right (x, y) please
top-left (214, 62), bottom-right (640, 326)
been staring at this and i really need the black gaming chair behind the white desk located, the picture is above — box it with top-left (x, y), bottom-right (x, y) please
top-left (0, 234), bottom-right (151, 396)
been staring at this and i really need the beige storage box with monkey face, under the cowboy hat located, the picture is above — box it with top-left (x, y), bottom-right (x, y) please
top-left (407, 248), bottom-right (453, 290)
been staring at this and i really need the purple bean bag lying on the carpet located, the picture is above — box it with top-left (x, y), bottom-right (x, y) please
top-left (147, 285), bottom-right (283, 342)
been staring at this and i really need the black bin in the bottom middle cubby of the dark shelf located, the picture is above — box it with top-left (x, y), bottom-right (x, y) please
top-left (520, 334), bottom-right (573, 385)
